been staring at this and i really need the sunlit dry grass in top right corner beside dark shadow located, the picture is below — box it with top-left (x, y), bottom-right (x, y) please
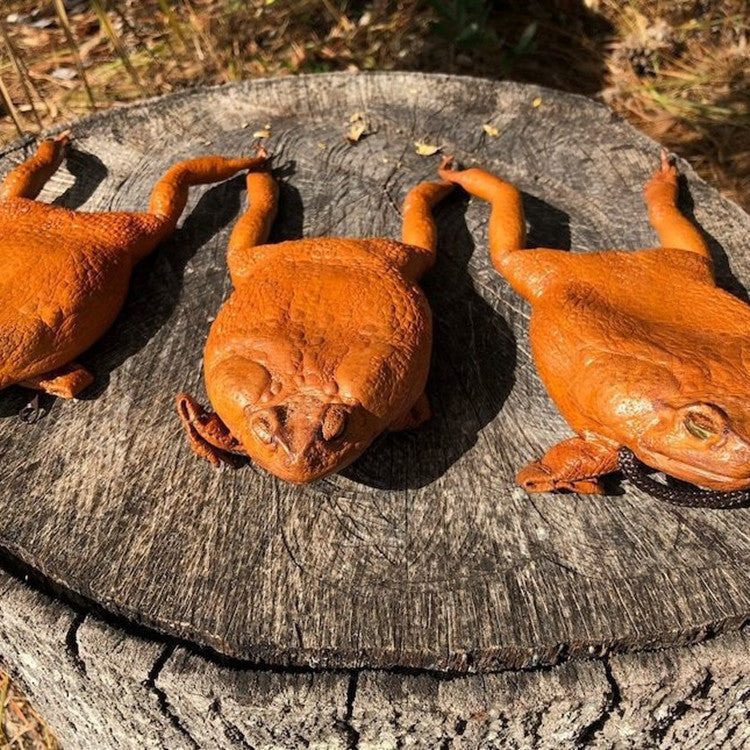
top-left (604, 0), bottom-right (750, 210)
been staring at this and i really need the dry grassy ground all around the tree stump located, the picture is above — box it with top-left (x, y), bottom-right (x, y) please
top-left (0, 0), bottom-right (750, 750)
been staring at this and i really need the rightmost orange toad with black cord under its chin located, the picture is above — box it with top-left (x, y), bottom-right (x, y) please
top-left (440, 152), bottom-right (750, 493)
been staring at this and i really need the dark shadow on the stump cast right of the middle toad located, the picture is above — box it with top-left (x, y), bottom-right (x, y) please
top-left (343, 195), bottom-right (516, 490)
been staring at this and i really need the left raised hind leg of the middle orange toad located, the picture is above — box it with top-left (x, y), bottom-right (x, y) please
top-left (227, 162), bottom-right (279, 284)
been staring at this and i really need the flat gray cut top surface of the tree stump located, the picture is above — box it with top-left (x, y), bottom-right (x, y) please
top-left (0, 73), bottom-right (750, 668)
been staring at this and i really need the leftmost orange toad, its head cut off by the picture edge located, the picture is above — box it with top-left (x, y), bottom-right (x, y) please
top-left (0, 133), bottom-right (263, 398)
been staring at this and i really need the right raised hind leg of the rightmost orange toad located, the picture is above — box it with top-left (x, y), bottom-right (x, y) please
top-left (643, 149), bottom-right (711, 261)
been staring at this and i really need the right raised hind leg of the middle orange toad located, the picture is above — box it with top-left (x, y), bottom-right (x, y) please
top-left (401, 180), bottom-right (453, 281)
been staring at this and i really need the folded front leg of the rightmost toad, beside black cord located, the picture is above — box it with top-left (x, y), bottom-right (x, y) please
top-left (516, 437), bottom-right (618, 495)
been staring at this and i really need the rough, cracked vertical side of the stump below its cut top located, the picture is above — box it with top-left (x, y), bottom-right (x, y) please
top-left (0, 571), bottom-right (750, 750)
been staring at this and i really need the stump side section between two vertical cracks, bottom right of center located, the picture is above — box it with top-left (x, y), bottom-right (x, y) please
top-left (352, 662), bottom-right (609, 750)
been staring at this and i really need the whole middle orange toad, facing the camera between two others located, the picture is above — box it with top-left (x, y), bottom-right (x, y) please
top-left (177, 164), bottom-right (452, 483)
